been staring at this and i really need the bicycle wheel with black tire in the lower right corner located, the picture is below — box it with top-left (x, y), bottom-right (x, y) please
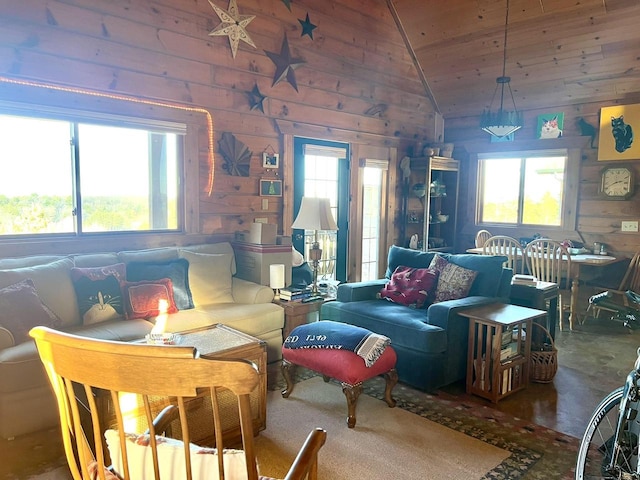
top-left (575, 387), bottom-right (638, 480)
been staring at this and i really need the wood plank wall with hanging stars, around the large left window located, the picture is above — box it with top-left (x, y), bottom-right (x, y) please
top-left (0, 0), bottom-right (435, 256)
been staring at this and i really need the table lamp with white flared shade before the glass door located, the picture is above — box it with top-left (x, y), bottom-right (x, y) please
top-left (291, 197), bottom-right (338, 297)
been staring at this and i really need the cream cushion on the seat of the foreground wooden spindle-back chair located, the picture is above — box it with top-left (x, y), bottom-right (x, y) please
top-left (104, 430), bottom-right (247, 480)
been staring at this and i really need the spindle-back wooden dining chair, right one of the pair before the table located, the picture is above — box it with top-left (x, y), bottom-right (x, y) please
top-left (523, 238), bottom-right (573, 330)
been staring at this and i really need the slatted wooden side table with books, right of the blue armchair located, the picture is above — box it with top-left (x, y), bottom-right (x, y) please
top-left (459, 303), bottom-right (547, 403)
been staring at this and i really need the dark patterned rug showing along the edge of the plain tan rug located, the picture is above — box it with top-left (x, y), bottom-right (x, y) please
top-left (269, 367), bottom-right (580, 480)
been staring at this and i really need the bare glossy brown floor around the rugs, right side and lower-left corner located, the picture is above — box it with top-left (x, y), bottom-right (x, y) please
top-left (0, 312), bottom-right (640, 480)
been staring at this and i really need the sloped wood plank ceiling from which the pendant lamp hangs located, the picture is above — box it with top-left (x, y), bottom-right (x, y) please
top-left (387, 0), bottom-right (640, 122)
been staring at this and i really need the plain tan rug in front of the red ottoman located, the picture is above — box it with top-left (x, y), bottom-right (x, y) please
top-left (256, 377), bottom-right (510, 480)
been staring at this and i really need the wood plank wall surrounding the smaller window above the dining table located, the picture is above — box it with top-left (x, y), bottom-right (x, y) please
top-left (445, 98), bottom-right (640, 257)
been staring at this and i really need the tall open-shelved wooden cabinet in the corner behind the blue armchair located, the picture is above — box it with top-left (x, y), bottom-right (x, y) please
top-left (401, 157), bottom-right (460, 252)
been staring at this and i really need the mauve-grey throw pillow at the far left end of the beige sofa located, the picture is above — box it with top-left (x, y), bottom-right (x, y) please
top-left (0, 279), bottom-right (60, 345)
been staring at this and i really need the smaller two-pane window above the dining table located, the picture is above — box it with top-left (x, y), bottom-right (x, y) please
top-left (477, 150), bottom-right (575, 228)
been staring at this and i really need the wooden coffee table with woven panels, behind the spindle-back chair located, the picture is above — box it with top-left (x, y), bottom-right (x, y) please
top-left (96, 324), bottom-right (267, 446)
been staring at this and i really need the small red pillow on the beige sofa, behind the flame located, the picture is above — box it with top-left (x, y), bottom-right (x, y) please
top-left (122, 278), bottom-right (178, 320)
